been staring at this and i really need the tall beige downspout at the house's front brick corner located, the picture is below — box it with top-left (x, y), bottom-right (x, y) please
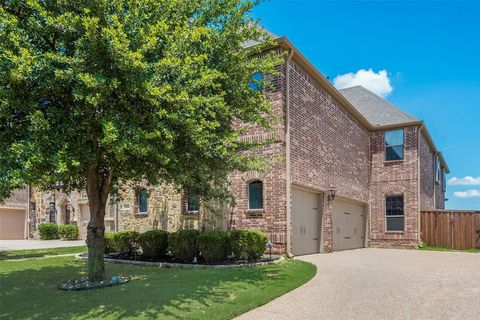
top-left (285, 49), bottom-right (294, 257)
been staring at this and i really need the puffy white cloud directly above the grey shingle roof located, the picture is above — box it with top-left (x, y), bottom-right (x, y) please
top-left (333, 69), bottom-right (393, 97)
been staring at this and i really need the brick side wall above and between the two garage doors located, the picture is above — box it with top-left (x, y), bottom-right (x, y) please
top-left (289, 61), bottom-right (370, 251)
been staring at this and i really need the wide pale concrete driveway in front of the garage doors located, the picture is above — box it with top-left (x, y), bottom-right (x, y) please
top-left (238, 249), bottom-right (480, 320)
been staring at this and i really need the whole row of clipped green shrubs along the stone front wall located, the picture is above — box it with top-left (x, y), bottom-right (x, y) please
top-left (105, 229), bottom-right (267, 262)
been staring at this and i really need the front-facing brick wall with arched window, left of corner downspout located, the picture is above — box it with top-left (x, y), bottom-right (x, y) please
top-left (229, 57), bottom-right (287, 252)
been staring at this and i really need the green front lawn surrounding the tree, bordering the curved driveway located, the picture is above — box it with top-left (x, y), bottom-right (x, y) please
top-left (0, 257), bottom-right (316, 320)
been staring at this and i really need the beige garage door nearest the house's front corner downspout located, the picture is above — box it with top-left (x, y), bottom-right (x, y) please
top-left (292, 189), bottom-right (320, 255)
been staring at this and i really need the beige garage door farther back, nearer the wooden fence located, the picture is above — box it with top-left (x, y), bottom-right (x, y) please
top-left (332, 199), bottom-right (365, 250)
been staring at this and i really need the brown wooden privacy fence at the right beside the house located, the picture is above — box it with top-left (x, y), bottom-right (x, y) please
top-left (420, 210), bottom-right (480, 250)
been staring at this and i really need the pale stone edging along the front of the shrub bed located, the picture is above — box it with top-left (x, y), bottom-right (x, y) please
top-left (75, 253), bottom-right (285, 269)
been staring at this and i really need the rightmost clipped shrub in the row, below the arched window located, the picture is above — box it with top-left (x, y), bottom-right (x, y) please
top-left (230, 229), bottom-right (267, 260)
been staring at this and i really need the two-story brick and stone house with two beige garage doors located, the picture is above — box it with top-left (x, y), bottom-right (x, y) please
top-left (0, 30), bottom-right (449, 255)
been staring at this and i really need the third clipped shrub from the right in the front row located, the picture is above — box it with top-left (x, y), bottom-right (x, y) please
top-left (168, 230), bottom-right (199, 261)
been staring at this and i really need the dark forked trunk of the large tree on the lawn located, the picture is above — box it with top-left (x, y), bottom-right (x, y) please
top-left (87, 166), bottom-right (111, 282)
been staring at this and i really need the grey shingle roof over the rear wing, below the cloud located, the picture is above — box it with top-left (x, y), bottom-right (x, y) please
top-left (339, 86), bottom-right (419, 127)
